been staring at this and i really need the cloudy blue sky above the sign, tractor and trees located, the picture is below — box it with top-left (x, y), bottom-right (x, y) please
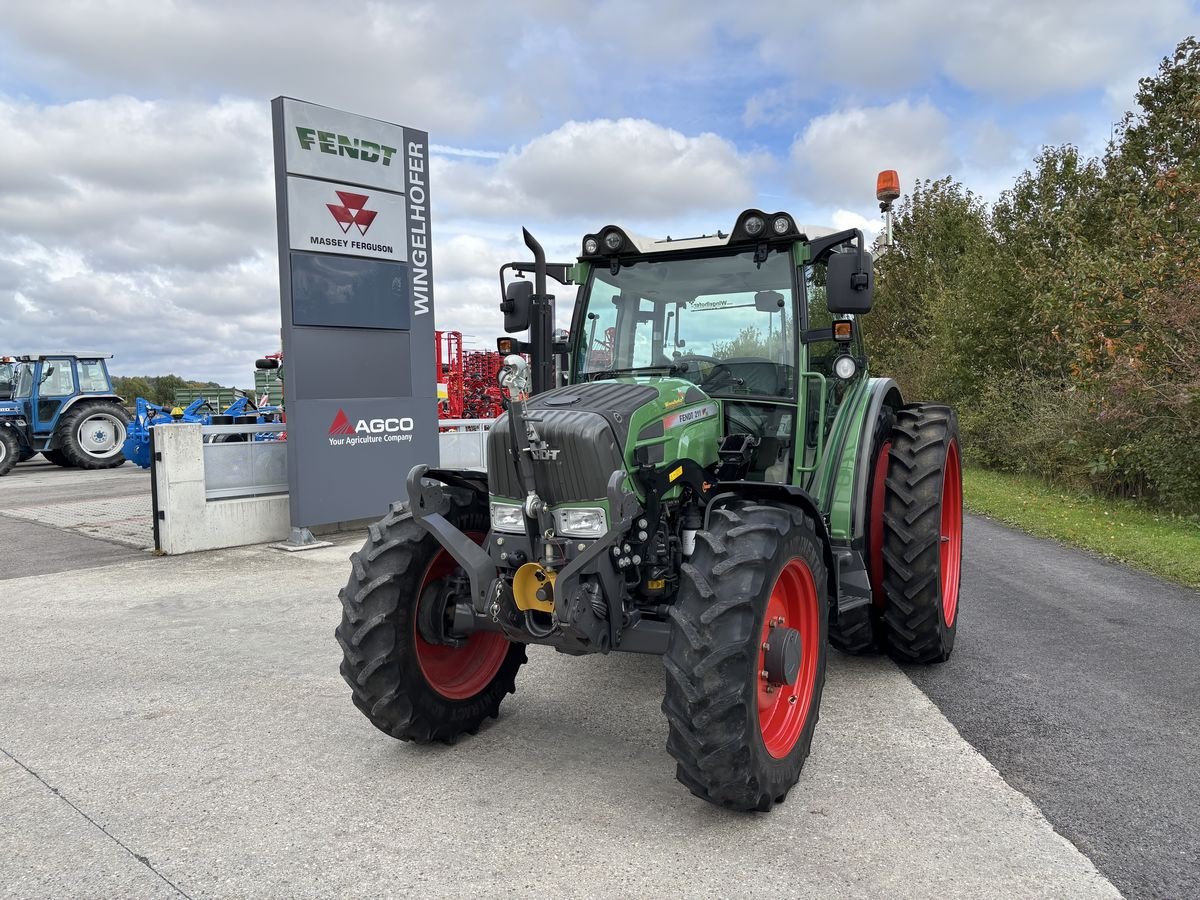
top-left (0, 0), bottom-right (1200, 384)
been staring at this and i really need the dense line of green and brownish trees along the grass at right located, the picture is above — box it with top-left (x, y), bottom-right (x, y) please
top-left (863, 37), bottom-right (1200, 514)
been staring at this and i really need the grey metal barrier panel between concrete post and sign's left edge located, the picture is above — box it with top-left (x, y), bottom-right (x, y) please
top-left (200, 424), bottom-right (288, 500)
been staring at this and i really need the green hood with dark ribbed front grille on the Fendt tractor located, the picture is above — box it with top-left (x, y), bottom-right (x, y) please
top-left (487, 378), bottom-right (721, 505)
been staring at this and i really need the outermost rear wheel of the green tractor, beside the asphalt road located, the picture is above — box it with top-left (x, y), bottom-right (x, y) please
top-left (882, 403), bottom-right (962, 662)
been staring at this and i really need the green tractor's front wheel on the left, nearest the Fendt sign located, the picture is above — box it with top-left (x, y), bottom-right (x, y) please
top-left (334, 488), bottom-right (526, 744)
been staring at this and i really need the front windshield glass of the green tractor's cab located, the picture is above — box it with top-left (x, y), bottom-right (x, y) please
top-left (577, 248), bottom-right (796, 396)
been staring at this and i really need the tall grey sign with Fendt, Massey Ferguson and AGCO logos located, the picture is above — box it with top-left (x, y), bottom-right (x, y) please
top-left (271, 97), bottom-right (438, 528)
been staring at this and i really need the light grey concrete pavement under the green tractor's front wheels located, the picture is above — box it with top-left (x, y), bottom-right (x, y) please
top-left (0, 541), bottom-right (1117, 898)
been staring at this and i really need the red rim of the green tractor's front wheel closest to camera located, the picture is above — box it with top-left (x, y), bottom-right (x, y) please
top-left (755, 559), bottom-right (821, 760)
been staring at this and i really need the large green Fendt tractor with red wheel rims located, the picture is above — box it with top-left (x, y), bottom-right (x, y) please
top-left (336, 209), bottom-right (962, 810)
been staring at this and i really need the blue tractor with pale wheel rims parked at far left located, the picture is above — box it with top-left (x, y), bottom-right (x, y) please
top-left (0, 353), bottom-right (130, 475)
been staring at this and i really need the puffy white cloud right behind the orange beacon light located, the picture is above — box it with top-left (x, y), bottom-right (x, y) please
top-left (791, 100), bottom-right (956, 204)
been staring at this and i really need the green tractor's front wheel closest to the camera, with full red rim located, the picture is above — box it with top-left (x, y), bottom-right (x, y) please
top-left (662, 503), bottom-right (829, 811)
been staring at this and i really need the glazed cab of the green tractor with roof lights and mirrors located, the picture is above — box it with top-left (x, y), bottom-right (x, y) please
top-left (500, 209), bottom-right (872, 487)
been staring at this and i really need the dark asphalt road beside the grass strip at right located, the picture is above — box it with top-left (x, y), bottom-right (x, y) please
top-left (907, 517), bottom-right (1200, 898)
